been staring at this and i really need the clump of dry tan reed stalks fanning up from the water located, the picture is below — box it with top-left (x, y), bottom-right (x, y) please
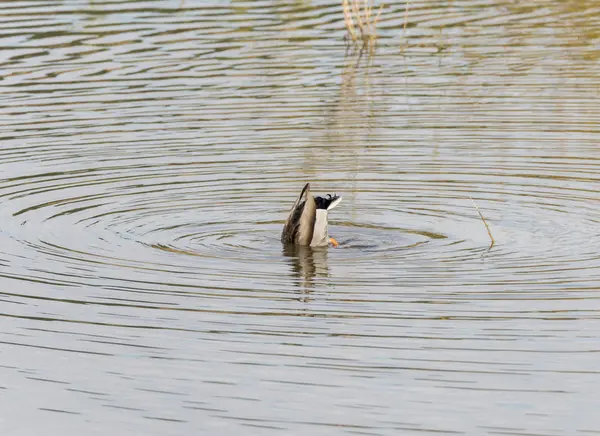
top-left (342, 0), bottom-right (383, 45)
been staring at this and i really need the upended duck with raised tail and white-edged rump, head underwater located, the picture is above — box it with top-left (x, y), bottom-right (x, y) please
top-left (281, 183), bottom-right (342, 247)
